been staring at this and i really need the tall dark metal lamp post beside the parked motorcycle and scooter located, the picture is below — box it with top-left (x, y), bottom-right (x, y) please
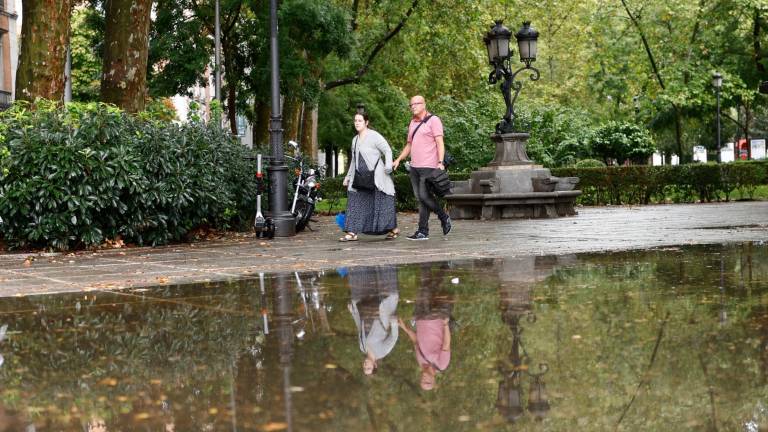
top-left (267, 0), bottom-right (296, 237)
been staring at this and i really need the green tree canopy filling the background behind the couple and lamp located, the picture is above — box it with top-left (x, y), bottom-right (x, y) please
top-left (16, 0), bottom-right (768, 165)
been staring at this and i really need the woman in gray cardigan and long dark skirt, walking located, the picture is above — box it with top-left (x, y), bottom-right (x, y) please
top-left (339, 113), bottom-right (400, 242)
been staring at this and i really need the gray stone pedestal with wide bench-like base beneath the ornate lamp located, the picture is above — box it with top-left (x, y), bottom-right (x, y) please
top-left (446, 133), bottom-right (581, 220)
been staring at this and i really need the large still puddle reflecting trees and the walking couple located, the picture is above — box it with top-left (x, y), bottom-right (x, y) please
top-left (0, 243), bottom-right (768, 431)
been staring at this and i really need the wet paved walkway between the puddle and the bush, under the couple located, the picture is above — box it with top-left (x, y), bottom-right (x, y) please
top-left (0, 202), bottom-right (768, 296)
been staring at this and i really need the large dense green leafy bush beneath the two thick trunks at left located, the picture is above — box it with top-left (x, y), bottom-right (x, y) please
top-left (0, 101), bottom-right (254, 250)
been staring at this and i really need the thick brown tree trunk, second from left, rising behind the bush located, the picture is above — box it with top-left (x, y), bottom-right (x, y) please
top-left (101, 0), bottom-right (152, 112)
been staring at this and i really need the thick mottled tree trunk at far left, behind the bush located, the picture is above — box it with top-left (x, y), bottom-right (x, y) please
top-left (16, 0), bottom-right (72, 101)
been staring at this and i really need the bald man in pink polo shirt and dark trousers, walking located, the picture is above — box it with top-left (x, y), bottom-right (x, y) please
top-left (392, 96), bottom-right (451, 240)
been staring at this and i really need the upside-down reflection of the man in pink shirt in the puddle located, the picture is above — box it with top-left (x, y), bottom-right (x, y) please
top-left (398, 264), bottom-right (452, 390)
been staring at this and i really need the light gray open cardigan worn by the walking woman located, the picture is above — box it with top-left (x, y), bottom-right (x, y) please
top-left (345, 129), bottom-right (395, 196)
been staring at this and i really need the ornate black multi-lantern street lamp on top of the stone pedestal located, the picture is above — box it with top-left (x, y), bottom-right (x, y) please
top-left (483, 20), bottom-right (539, 134)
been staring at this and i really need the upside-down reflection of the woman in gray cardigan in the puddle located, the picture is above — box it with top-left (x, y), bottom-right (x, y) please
top-left (348, 267), bottom-right (399, 375)
